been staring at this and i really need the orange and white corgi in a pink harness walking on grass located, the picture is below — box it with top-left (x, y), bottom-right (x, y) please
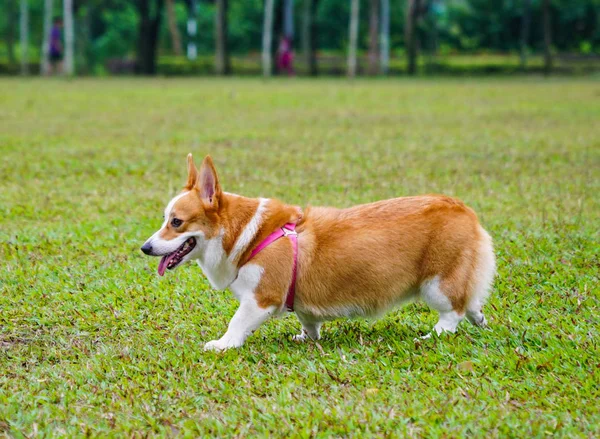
top-left (141, 154), bottom-right (495, 350)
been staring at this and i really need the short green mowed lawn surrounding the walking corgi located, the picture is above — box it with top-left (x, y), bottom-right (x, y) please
top-left (0, 78), bottom-right (600, 438)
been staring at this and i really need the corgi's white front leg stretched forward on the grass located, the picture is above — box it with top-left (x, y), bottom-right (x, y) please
top-left (204, 297), bottom-right (277, 351)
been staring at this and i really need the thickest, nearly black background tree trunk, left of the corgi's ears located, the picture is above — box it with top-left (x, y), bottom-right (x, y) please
top-left (137, 0), bottom-right (163, 75)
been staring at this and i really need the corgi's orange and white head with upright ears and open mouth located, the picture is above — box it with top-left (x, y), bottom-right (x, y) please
top-left (141, 154), bottom-right (223, 276)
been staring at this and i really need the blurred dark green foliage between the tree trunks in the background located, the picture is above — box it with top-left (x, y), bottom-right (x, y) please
top-left (0, 0), bottom-right (600, 75)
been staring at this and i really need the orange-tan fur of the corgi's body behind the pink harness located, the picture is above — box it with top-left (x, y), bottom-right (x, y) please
top-left (296, 196), bottom-right (491, 320)
